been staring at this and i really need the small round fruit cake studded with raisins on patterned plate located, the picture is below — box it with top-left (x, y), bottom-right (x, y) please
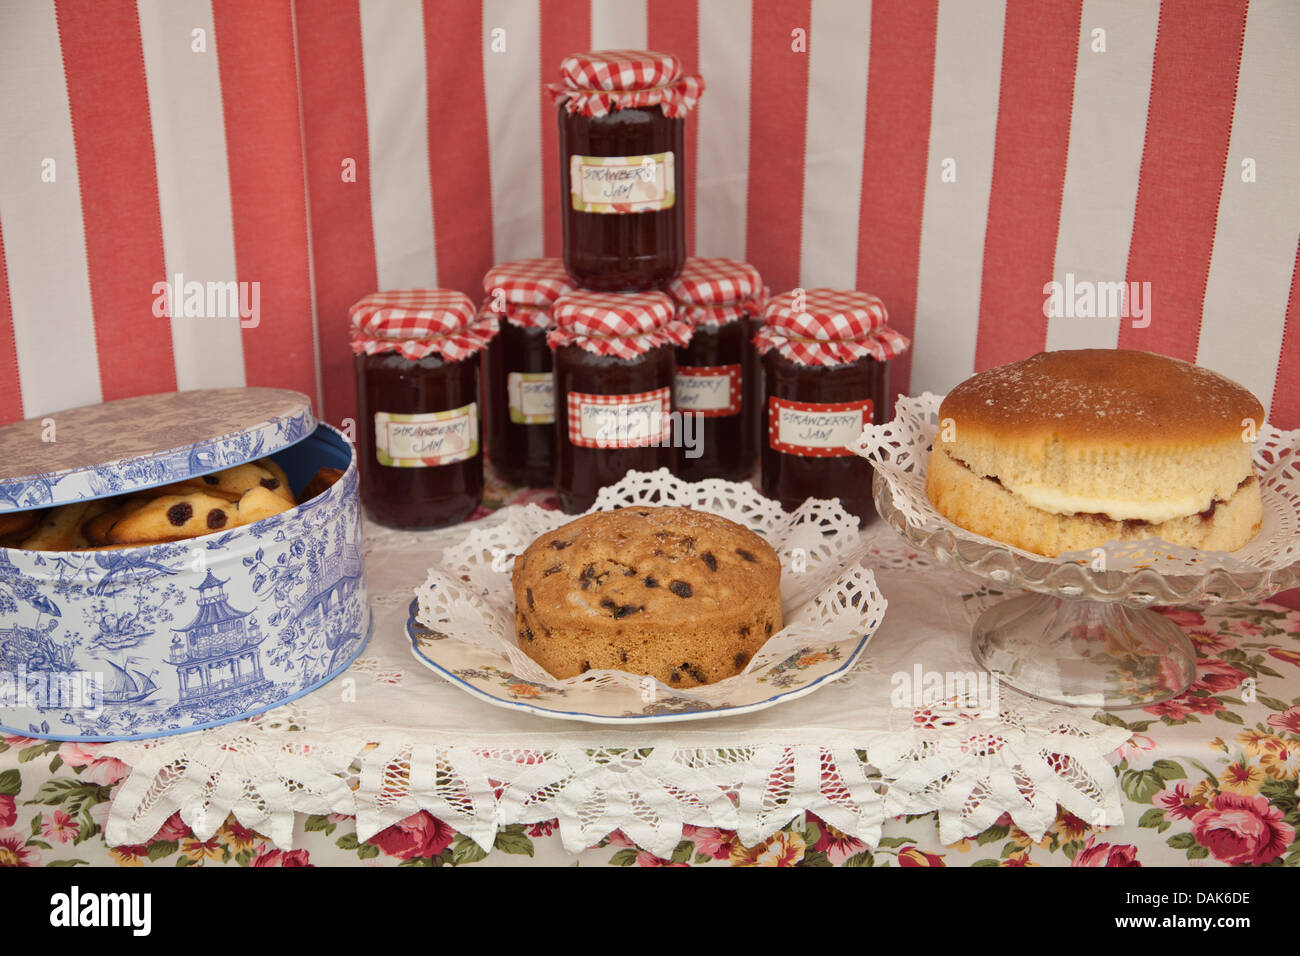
top-left (512, 507), bottom-right (781, 687)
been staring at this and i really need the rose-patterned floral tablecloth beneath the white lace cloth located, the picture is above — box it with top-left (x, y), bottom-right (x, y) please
top-left (0, 484), bottom-right (1300, 866)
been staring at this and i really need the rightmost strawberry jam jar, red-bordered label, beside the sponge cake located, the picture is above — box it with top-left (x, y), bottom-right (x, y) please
top-left (755, 289), bottom-right (910, 524)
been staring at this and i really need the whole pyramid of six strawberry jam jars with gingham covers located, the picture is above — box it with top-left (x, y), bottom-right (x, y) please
top-left (352, 49), bottom-right (907, 528)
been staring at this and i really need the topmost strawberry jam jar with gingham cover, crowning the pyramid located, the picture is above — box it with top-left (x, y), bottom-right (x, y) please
top-left (549, 49), bottom-right (705, 291)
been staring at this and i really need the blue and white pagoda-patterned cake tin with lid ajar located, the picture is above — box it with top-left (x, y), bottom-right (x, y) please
top-left (0, 389), bottom-right (371, 740)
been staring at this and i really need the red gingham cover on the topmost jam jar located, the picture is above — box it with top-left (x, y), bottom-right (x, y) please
top-left (546, 49), bottom-right (705, 117)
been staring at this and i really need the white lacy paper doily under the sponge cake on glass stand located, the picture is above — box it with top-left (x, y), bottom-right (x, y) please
top-left (853, 392), bottom-right (1300, 602)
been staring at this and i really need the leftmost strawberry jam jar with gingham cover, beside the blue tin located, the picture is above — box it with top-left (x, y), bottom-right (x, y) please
top-left (348, 289), bottom-right (497, 531)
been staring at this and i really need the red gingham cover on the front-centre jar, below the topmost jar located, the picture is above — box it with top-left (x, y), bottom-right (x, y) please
top-left (546, 291), bottom-right (692, 359)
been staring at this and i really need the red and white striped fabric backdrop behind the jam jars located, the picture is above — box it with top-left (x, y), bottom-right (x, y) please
top-left (0, 0), bottom-right (1300, 427)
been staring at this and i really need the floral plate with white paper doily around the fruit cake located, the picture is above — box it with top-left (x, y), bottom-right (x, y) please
top-left (410, 468), bottom-right (887, 723)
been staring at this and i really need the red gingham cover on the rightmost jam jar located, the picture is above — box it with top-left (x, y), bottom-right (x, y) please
top-left (754, 289), bottom-right (911, 365)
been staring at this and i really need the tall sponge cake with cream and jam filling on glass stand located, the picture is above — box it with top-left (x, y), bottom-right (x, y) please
top-left (926, 349), bottom-right (1265, 555)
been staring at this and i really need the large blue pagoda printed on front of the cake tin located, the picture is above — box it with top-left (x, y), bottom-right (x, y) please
top-left (168, 571), bottom-right (272, 710)
